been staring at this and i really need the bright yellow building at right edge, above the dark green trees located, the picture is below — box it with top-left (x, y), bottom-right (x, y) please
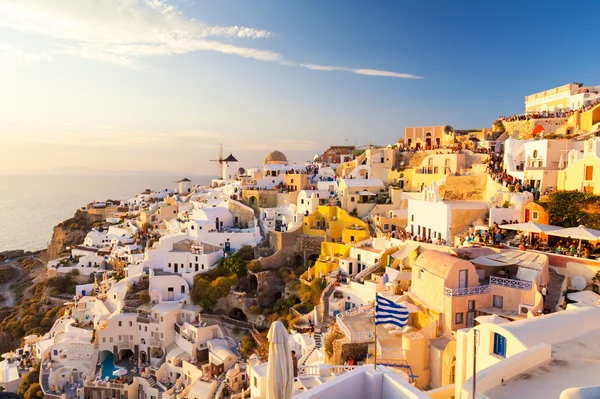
top-left (557, 137), bottom-right (600, 194)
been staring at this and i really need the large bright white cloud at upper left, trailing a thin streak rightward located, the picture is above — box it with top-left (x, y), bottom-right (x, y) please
top-left (0, 0), bottom-right (420, 79)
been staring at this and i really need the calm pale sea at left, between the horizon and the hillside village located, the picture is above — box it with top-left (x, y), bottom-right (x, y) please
top-left (0, 175), bottom-right (212, 252)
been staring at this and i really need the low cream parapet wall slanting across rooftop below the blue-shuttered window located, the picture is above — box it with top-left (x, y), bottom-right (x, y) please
top-left (461, 343), bottom-right (552, 399)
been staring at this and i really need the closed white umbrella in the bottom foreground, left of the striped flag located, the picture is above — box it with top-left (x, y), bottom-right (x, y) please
top-left (267, 321), bottom-right (294, 399)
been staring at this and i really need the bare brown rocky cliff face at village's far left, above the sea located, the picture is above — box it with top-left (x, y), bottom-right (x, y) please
top-left (41, 211), bottom-right (102, 263)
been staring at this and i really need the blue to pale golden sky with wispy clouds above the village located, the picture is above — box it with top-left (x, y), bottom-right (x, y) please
top-left (0, 0), bottom-right (600, 174)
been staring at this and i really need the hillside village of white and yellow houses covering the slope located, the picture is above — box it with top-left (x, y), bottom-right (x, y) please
top-left (0, 83), bottom-right (600, 399)
